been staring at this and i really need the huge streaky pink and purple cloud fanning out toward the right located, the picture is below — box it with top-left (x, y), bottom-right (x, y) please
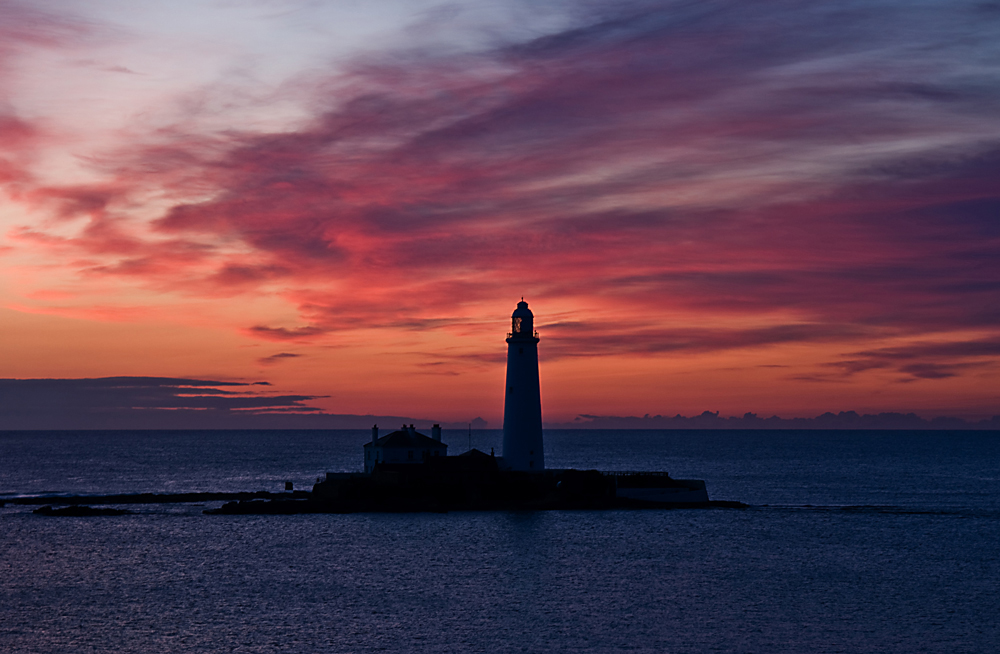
top-left (0, 2), bottom-right (1000, 394)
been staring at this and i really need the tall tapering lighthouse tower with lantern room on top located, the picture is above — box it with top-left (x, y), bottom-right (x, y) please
top-left (503, 298), bottom-right (545, 472)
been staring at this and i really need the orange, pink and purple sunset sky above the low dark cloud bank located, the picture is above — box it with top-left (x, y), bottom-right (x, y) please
top-left (0, 0), bottom-right (1000, 427)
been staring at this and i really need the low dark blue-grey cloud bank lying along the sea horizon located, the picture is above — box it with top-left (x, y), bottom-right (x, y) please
top-left (0, 377), bottom-right (1000, 430)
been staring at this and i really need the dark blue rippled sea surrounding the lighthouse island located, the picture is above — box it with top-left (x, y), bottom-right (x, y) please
top-left (0, 430), bottom-right (1000, 654)
